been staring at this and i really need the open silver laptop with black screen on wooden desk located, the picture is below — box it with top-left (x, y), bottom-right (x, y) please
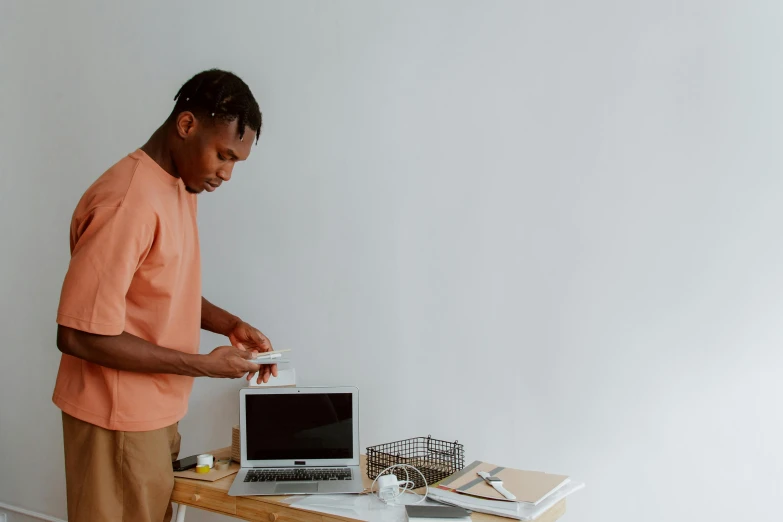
top-left (228, 387), bottom-right (364, 496)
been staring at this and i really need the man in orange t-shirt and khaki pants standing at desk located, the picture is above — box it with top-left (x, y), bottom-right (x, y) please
top-left (53, 70), bottom-right (277, 522)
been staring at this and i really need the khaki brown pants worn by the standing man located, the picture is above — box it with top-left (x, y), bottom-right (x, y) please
top-left (63, 413), bottom-right (180, 522)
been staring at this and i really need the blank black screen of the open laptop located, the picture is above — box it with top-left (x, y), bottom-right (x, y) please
top-left (245, 393), bottom-right (354, 460)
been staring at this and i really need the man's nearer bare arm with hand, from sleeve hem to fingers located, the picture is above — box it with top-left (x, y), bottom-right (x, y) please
top-left (57, 326), bottom-right (260, 378)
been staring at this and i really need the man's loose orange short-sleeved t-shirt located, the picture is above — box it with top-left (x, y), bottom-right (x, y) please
top-left (52, 150), bottom-right (201, 431)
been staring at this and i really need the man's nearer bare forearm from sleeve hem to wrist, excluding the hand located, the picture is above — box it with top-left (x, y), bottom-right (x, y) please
top-left (57, 326), bottom-right (207, 377)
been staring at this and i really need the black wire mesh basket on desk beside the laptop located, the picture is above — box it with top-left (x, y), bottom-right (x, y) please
top-left (367, 435), bottom-right (465, 488)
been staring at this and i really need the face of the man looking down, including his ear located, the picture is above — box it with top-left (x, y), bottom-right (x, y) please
top-left (174, 112), bottom-right (256, 194)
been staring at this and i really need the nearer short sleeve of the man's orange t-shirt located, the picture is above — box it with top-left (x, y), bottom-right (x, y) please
top-left (57, 207), bottom-right (154, 335)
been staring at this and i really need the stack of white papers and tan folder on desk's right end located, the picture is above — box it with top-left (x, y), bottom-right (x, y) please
top-left (429, 461), bottom-right (584, 520)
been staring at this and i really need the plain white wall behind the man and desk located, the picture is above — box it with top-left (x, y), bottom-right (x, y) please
top-left (0, 0), bottom-right (783, 522)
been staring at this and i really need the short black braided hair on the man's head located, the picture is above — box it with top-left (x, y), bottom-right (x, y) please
top-left (171, 69), bottom-right (262, 143)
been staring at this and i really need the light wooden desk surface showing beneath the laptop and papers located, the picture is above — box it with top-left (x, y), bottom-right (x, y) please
top-left (171, 448), bottom-right (566, 522)
